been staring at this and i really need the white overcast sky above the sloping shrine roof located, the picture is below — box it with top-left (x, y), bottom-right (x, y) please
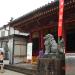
top-left (0, 0), bottom-right (54, 27)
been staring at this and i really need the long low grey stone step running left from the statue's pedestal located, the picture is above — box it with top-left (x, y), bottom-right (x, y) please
top-left (4, 65), bottom-right (36, 75)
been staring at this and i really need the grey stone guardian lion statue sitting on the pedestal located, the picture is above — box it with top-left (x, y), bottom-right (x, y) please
top-left (44, 34), bottom-right (58, 54)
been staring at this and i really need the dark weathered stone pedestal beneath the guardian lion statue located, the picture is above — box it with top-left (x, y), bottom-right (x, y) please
top-left (37, 53), bottom-right (65, 75)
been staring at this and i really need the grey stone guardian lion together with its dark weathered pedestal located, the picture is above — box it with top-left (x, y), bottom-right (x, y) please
top-left (36, 34), bottom-right (65, 75)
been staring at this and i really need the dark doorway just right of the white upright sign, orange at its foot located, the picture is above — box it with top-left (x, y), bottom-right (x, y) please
top-left (31, 32), bottom-right (39, 63)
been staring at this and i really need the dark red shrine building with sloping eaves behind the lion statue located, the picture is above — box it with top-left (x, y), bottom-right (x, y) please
top-left (9, 0), bottom-right (75, 62)
